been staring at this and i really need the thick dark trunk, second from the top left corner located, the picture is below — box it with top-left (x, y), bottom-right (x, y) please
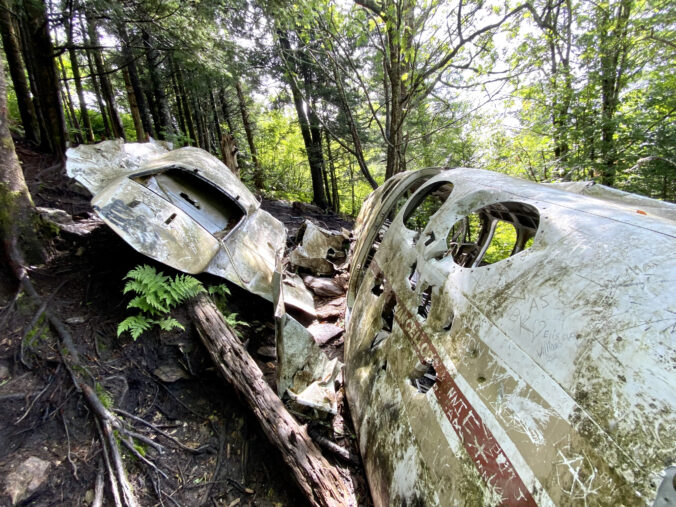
top-left (22, 0), bottom-right (66, 158)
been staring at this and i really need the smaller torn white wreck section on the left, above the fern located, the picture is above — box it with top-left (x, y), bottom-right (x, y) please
top-left (66, 141), bottom-right (298, 308)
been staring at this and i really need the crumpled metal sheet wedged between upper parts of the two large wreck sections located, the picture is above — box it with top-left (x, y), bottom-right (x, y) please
top-left (289, 220), bottom-right (349, 275)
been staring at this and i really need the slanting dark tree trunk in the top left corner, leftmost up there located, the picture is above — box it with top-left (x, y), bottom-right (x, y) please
top-left (0, 0), bottom-right (40, 145)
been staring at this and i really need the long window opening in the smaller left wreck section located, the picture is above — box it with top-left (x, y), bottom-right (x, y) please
top-left (132, 168), bottom-right (245, 239)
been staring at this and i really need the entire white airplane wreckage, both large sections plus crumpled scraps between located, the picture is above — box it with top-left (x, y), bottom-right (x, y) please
top-left (67, 141), bottom-right (676, 506)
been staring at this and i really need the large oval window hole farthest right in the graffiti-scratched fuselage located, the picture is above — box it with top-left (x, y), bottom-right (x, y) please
top-left (445, 202), bottom-right (540, 268)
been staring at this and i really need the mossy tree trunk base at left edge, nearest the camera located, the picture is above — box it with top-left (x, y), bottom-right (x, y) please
top-left (0, 58), bottom-right (45, 272)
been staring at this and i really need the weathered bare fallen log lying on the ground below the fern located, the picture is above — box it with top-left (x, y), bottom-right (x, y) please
top-left (190, 295), bottom-right (357, 507)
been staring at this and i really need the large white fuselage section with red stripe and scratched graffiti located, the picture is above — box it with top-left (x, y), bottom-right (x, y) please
top-left (345, 169), bottom-right (676, 505)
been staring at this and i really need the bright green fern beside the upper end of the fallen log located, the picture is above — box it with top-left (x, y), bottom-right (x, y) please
top-left (117, 265), bottom-right (205, 340)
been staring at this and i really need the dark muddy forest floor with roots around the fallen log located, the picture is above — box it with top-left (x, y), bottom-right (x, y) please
top-left (0, 144), bottom-right (370, 506)
